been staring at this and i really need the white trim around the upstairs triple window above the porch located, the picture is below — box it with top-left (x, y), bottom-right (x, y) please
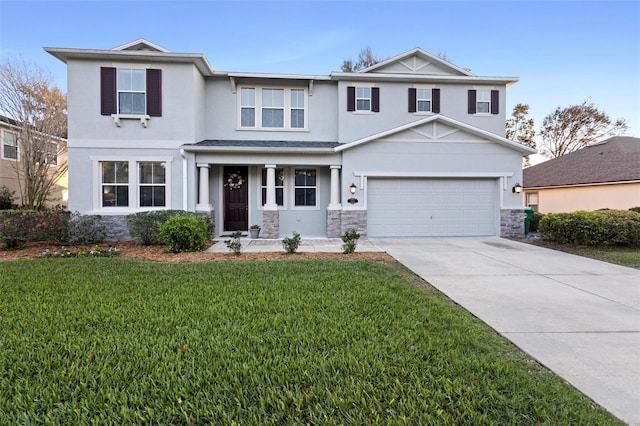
top-left (236, 85), bottom-right (309, 132)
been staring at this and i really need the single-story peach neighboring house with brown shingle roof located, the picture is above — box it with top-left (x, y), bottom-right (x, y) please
top-left (523, 136), bottom-right (640, 213)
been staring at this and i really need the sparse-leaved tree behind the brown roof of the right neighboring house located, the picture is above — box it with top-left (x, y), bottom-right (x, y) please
top-left (540, 101), bottom-right (628, 158)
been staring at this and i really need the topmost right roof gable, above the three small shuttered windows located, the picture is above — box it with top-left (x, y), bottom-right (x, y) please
top-left (359, 48), bottom-right (473, 77)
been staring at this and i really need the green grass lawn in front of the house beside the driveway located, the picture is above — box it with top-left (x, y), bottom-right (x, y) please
top-left (0, 258), bottom-right (621, 425)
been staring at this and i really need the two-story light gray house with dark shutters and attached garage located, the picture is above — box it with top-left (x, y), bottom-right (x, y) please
top-left (45, 39), bottom-right (535, 238)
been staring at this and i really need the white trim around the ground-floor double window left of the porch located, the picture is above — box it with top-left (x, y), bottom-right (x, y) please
top-left (89, 156), bottom-right (173, 215)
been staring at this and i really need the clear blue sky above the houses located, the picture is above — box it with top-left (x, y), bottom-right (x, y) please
top-left (0, 0), bottom-right (640, 145)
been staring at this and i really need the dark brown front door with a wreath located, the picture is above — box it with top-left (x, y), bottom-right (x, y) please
top-left (223, 166), bottom-right (249, 231)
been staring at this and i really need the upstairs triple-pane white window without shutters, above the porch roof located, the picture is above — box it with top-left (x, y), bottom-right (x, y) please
top-left (239, 87), bottom-right (307, 130)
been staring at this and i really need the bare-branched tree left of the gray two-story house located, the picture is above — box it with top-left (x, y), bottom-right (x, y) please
top-left (0, 60), bottom-right (67, 209)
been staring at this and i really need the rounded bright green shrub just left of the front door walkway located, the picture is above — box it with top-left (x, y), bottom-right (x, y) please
top-left (159, 212), bottom-right (210, 253)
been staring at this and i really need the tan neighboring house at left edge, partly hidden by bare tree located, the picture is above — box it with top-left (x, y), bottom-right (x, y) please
top-left (0, 116), bottom-right (68, 207)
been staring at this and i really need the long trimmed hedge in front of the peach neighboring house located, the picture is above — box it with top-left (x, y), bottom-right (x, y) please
top-left (538, 210), bottom-right (640, 247)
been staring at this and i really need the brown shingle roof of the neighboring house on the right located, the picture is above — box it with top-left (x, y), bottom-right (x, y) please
top-left (522, 136), bottom-right (640, 189)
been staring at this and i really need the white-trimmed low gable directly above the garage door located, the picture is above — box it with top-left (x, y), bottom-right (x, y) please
top-left (336, 115), bottom-right (536, 155)
